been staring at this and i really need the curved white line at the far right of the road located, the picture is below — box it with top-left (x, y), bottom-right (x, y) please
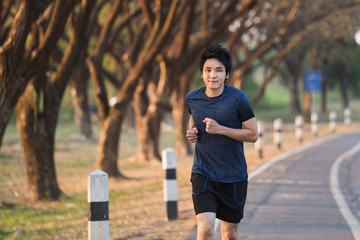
top-left (330, 143), bottom-right (360, 240)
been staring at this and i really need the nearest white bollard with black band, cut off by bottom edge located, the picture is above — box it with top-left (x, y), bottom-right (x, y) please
top-left (88, 169), bottom-right (110, 240)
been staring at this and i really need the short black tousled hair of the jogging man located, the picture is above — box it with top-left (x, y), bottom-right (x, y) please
top-left (199, 44), bottom-right (232, 75)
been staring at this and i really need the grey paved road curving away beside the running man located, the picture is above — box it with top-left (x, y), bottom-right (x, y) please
top-left (189, 133), bottom-right (360, 240)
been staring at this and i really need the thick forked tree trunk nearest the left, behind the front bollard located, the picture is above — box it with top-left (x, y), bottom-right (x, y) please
top-left (16, 0), bottom-right (95, 200)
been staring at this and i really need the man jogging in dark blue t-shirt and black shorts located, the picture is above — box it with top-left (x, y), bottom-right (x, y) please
top-left (186, 45), bottom-right (258, 240)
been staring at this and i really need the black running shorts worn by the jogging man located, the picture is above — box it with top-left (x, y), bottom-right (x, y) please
top-left (190, 173), bottom-right (248, 223)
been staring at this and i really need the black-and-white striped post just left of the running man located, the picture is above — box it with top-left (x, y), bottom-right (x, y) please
top-left (162, 148), bottom-right (178, 220)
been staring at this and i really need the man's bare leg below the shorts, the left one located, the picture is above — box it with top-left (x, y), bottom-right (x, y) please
top-left (196, 212), bottom-right (216, 240)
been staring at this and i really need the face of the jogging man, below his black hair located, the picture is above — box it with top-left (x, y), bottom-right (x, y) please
top-left (201, 58), bottom-right (229, 94)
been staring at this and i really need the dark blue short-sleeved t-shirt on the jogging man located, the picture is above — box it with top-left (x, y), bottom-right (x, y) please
top-left (186, 85), bottom-right (254, 182)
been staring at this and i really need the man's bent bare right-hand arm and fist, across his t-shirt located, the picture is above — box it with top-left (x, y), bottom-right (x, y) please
top-left (203, 117), bottom-right (259, 142)
